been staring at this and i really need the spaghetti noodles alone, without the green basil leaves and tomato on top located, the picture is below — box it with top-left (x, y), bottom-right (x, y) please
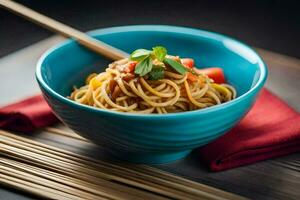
top-left (69, 47), bottom-right (236, 114)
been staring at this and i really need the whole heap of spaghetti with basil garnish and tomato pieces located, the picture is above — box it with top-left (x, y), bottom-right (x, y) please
top-left (70, 47), bottom-right (236, 114)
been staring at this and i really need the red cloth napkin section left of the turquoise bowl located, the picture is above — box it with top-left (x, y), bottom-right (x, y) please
top-left (0, 95), bottom-right (58, 132)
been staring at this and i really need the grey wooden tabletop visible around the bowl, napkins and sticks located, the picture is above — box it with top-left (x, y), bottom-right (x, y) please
top-left (0, 37), bottom-right (300, 200)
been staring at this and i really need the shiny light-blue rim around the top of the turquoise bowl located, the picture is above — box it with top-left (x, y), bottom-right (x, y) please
top-left (35, 25), bottom-right (268, 119)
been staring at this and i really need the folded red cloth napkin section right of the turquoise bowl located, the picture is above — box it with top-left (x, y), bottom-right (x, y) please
top-left (199, 89), bottom-right (300, 171)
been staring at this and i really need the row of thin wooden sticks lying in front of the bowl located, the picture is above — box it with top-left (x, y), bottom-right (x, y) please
top-left (0, 131), bottom-right (247, 199)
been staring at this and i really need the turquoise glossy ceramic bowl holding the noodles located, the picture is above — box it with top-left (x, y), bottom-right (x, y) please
top-left (36, 25), bottom-right (267, 163)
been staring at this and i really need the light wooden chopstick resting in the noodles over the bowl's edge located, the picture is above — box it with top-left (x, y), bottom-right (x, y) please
top-left (0, 0), bottom-right (129, 60)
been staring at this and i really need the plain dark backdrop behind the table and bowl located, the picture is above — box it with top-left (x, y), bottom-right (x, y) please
top-left (0, 0), bottom-right (300, 58)
